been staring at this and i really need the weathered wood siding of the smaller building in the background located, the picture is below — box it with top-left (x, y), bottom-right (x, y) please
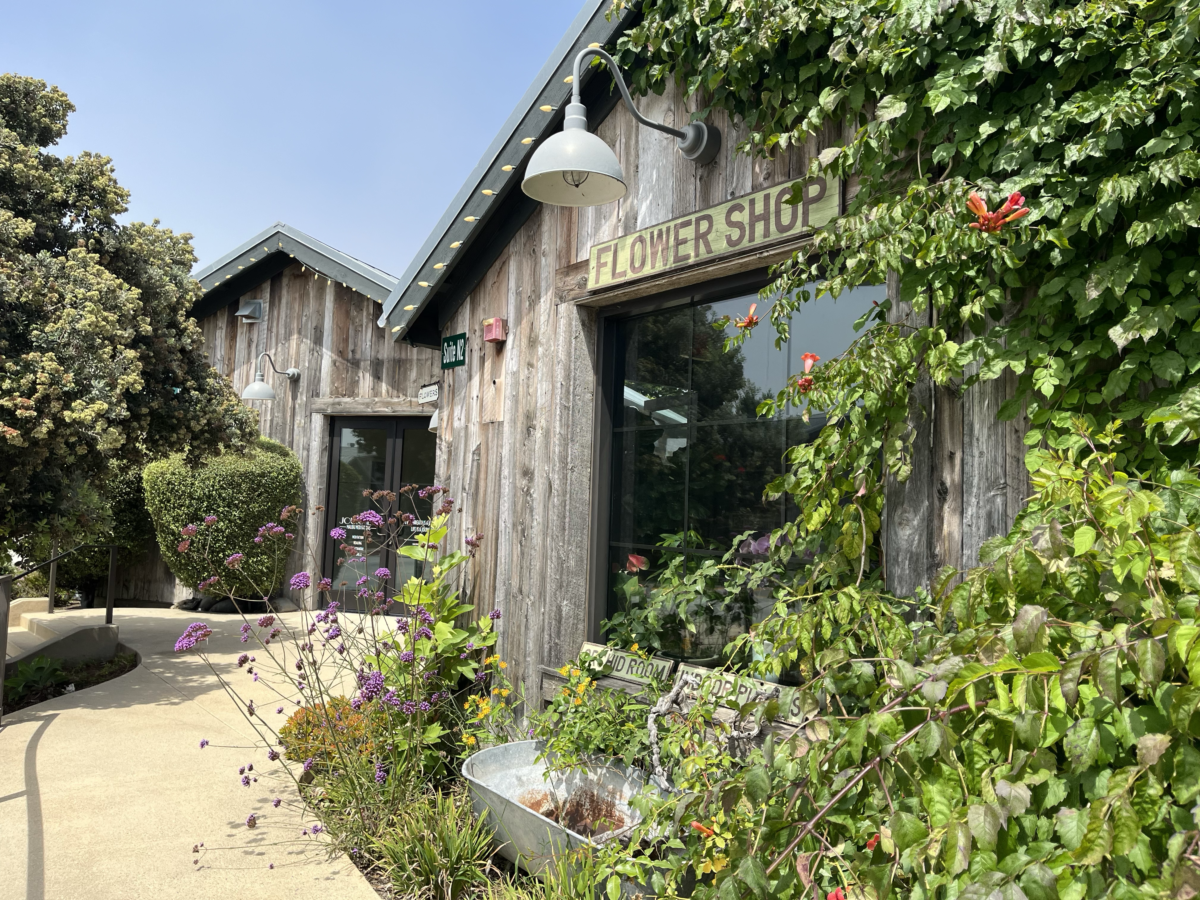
top-left (131, 263), bottom-right (438, 602)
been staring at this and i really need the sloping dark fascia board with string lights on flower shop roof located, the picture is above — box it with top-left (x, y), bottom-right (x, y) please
top-left (379, 0), bottom-right (636, 340)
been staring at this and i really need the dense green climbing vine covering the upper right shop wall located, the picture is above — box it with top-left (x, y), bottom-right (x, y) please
top-left (618, 0), bottom-right (1200, 592)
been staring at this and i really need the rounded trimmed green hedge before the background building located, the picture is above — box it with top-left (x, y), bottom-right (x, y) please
top-left (143, 438), bottom-right (302, 600)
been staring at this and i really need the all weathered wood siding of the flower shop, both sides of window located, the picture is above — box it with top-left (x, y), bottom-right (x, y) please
top-left (438, 82), bottom-right (1026, 697)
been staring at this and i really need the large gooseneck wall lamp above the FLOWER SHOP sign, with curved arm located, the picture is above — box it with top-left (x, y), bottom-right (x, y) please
top-left (521, 47), bottom-right (721, 206)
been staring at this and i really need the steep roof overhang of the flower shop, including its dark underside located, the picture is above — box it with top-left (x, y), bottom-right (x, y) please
top-left (379, 0), bottom-right (638, 346)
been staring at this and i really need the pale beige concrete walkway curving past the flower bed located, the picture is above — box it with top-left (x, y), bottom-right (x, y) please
top-left (0, 608), bottom-right (378, 900)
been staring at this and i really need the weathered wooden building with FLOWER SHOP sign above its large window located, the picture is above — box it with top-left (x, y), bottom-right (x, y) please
top-left (372, 0), bottom-right (1026, 710)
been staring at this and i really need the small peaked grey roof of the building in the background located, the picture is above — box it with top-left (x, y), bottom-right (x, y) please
top-left (192, 222), bottom-right (397, 319)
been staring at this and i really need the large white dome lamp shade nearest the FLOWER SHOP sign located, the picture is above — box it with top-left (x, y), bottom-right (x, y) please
top-left (521, 119), bottom-right (625, 206)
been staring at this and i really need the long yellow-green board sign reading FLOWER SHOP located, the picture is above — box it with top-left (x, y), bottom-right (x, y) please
top-left (588, 176), bottom-right (841, 290)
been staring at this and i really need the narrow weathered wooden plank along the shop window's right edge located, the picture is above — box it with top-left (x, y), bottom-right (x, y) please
top-left (883, 274), bottom-right (934, 596)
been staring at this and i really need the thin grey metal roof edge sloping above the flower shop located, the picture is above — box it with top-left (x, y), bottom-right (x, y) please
top-left (378, 0), bottom-right (635, 340)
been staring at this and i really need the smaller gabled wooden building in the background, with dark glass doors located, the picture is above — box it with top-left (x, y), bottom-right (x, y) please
top-left (121, 222), bottom-right (439, 604)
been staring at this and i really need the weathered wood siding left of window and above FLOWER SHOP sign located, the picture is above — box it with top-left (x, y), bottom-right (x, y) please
top-left (438, 79), bottom-right (868, 710)
